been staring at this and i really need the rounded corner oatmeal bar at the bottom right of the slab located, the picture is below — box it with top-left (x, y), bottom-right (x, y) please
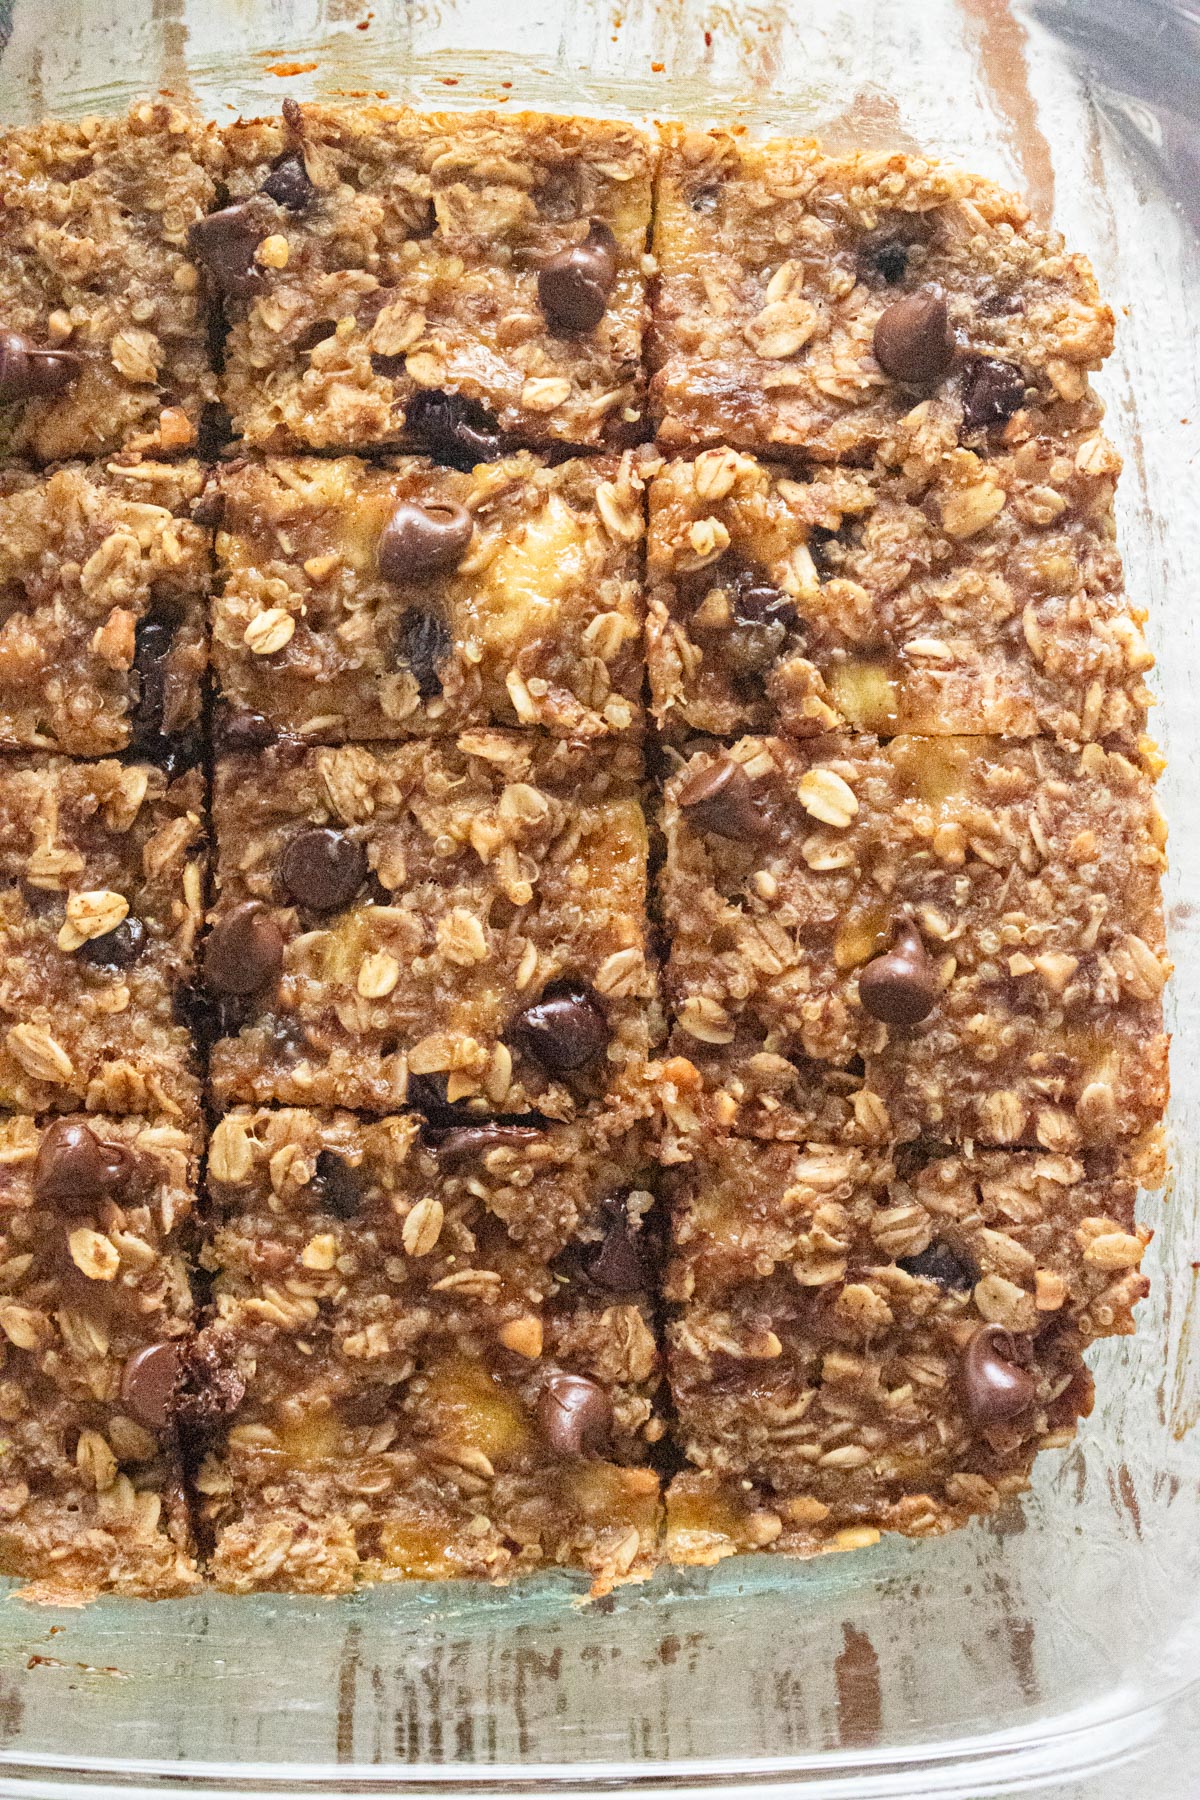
top-left (666, 1139), bottom-right (1150, 1562)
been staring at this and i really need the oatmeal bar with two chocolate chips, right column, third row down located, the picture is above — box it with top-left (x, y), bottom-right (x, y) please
top-left (662, 734), bottom-right (1168, 1152)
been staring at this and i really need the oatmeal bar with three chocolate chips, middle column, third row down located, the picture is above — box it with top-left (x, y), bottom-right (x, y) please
top-left (205, 729), bottom-right (655, 1118)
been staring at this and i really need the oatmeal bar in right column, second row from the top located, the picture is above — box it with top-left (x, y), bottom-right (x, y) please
top-left (648, 426), bottom-right (1153, 743)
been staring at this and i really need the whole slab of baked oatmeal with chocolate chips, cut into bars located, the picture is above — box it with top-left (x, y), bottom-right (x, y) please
top-left (0, 101), bottom-right (1168, 1598)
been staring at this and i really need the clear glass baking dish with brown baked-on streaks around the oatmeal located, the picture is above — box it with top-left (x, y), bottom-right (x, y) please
top-left (0, 0), bottom-right (1200, 1800)
